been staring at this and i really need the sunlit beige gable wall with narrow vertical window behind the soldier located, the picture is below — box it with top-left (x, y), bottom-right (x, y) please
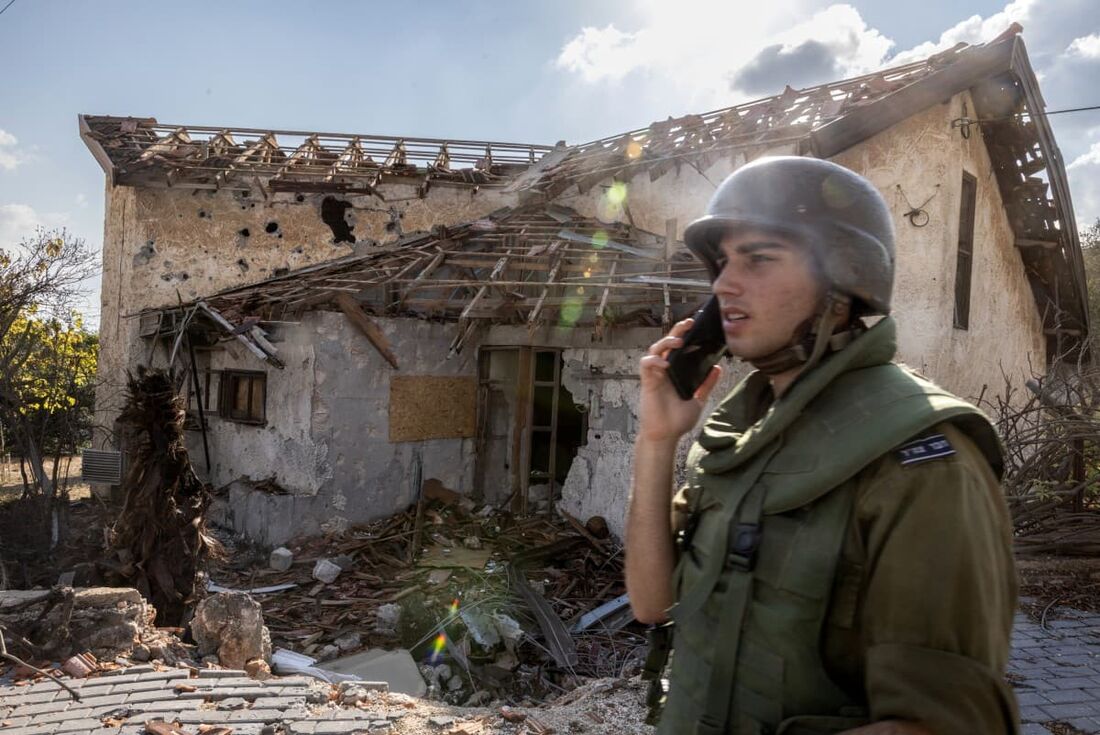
top-left (834, 94), bottom-right (1046, 399)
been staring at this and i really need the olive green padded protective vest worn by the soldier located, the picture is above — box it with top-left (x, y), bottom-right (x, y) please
top-left (658, 319), bottom-right (1001, 735)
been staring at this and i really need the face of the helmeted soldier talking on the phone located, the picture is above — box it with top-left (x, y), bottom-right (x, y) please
top-left (712, 229), bottom-right (823, 360)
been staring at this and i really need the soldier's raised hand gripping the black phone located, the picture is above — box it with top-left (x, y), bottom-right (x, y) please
top-left (638, 318), bottom-right (722, 442)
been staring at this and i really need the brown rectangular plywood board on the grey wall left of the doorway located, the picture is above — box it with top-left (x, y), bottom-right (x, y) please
top-left (389, 375), bottom-right (477, 441)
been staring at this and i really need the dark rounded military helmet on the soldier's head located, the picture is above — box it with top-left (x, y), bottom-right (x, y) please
top-left (684, 156), bottom-right (894, 315)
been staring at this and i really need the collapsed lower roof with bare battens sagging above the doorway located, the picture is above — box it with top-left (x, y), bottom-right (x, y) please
top-left (150, 205), bottom-right (710, 364)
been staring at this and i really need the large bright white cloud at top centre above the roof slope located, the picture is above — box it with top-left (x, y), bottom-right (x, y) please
top-left (556, 0), bottom-right (893, 113)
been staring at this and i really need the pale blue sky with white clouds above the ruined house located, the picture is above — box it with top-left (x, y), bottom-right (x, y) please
top-left (0, 0), bottom-right (1100, 325)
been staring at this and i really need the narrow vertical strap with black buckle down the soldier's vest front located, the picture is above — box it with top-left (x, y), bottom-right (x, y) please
top-left (695, 484), bottom-right (766, 735)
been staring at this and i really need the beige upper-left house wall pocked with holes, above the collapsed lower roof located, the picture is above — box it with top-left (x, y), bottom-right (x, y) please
top-left (96, 183), bottom-right (514, 446)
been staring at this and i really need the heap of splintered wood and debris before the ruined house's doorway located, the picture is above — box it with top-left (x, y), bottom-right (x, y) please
top-left (210, 488), bottom-right (645, 706)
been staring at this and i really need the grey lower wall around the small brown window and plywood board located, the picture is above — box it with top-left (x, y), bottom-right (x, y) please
top-left (196, 311), bottom-right (476, 545)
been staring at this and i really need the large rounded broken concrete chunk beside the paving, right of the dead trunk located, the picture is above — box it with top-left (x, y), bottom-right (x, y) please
top-left (191, 592), bottom-right (272, 674)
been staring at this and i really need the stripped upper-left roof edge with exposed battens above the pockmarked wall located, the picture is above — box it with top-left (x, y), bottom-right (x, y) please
top-left (79, 114), bottom-right (552, 193)
